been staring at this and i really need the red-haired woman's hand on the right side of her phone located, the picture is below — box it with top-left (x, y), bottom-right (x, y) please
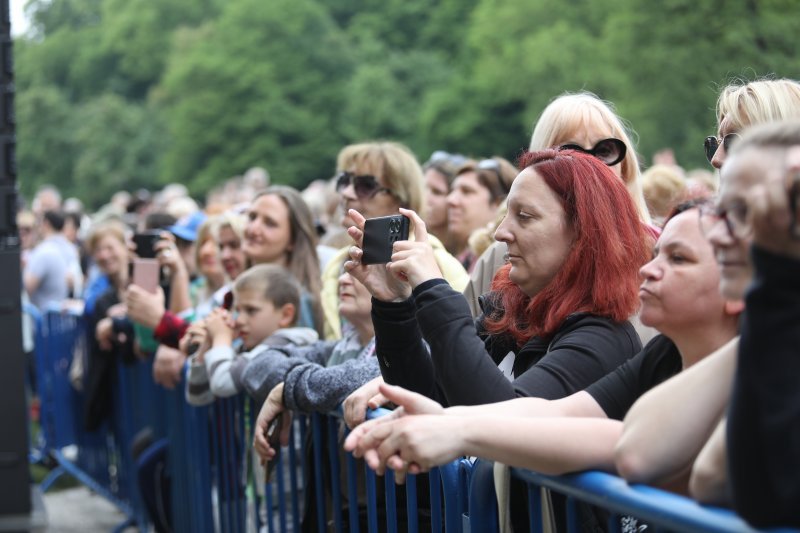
top-left (386, 208), bottom-right (442, 288)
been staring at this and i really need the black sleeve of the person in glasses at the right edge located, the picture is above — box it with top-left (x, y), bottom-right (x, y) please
top-left (727, 247), bottom-right (800, 527)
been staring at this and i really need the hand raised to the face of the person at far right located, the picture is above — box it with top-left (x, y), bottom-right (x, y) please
top-left (747, 146), bottom-right (800, 259)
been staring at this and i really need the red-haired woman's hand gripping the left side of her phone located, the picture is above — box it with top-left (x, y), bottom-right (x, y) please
top-left (344, 209), bottom-right (411, 302)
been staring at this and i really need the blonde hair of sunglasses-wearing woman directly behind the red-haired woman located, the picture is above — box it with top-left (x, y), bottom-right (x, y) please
top-left (528, 91), bottom-right (650, 223)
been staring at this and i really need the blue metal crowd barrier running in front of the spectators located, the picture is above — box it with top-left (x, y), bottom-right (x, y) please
top-left (31, 311), bottom-right (792, 533)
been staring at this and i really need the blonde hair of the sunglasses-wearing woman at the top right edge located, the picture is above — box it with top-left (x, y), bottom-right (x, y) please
top-left (717, 78), bottom-right (800, 132)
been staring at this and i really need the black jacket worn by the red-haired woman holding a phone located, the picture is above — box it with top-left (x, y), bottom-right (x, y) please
top-left (372, 280), bottom-right (642, 405)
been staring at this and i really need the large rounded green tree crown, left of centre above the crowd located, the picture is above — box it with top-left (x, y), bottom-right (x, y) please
top-left (158, 0), bottom-right (352, 192)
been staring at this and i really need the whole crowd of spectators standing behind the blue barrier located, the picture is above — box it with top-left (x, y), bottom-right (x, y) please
top-left (17, 79), bottom-right (800, 530)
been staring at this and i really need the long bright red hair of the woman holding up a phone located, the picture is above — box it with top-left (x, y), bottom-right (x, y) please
top-left (486, 150), bottom-right (651, 345)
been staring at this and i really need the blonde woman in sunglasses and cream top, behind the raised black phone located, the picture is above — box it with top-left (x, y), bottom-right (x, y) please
top-left (322, 142), bottom-right (468, 339)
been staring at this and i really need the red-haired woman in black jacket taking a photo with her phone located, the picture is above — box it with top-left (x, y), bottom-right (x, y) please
top-left (346, 150), bottom-right (649, 405)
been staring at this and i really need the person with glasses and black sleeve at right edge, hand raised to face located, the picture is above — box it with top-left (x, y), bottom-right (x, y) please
top-left (718, 120), bottom-right (800, 527)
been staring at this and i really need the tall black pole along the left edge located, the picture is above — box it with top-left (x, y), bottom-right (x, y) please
top-left (0, 0), bottom-right (31, 517)
